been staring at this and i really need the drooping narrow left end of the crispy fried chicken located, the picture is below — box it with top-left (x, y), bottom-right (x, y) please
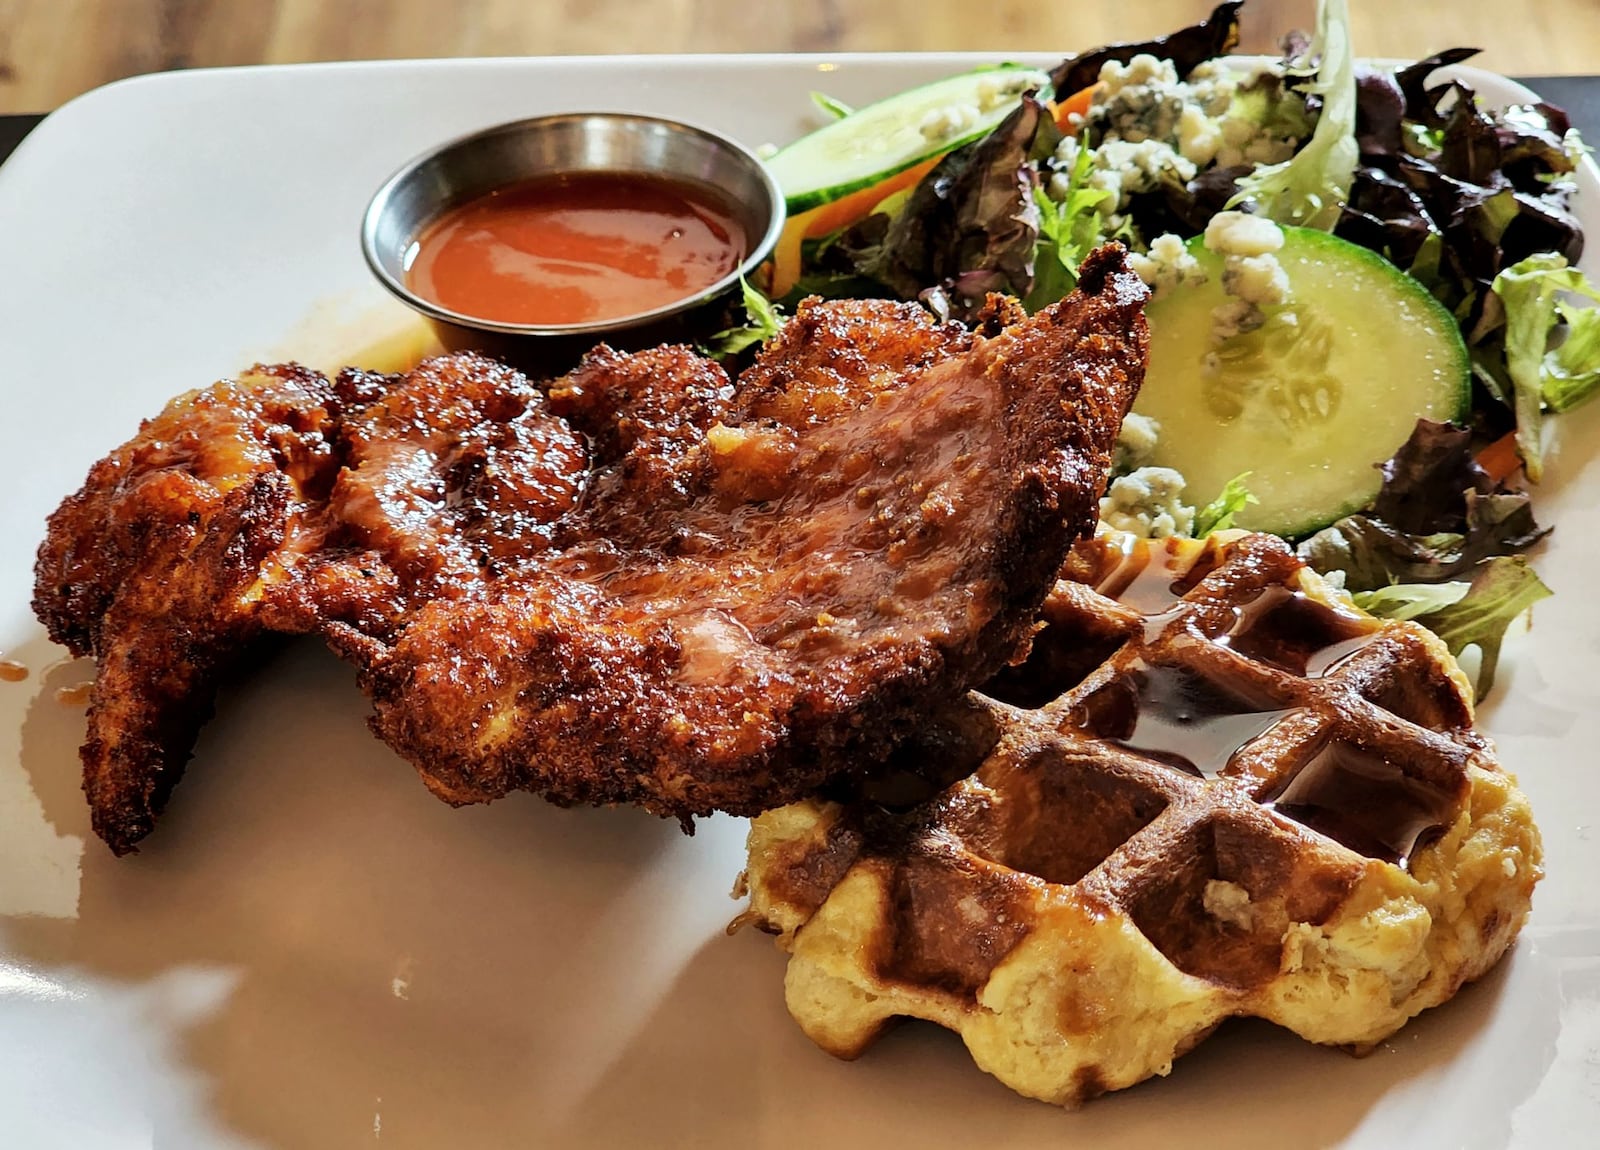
top-left (34, 366), bottom-right (336, 853)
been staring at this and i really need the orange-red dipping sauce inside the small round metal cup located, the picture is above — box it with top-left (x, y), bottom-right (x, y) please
top-left (406, 171), bottom-right (749, 325)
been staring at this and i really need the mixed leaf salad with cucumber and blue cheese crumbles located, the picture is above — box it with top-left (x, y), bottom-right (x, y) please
top-left (722, 0), bottom-right (1600, 694)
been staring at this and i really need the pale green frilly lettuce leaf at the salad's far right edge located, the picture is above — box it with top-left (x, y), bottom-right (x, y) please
top-left (1493, 253), bottom-right (1600, 481)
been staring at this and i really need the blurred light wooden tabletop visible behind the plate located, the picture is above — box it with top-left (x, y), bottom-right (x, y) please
top-left (0, 0), bottom-right (1600, 112)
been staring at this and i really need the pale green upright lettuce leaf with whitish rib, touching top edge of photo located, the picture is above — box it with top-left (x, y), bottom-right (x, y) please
top-left (1227, 0), bottom-right (1362, 232)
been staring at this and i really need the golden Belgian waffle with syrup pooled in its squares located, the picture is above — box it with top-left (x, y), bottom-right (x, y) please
top-left (747, 533), bottom-right (1541, 1105)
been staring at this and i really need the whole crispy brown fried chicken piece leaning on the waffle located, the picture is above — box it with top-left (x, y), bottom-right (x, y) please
top-left (35, 248), bottom-right (1146, 853)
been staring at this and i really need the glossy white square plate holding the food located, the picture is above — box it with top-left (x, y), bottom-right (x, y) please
top-left (0, 56), bottom-right (1600, 1150)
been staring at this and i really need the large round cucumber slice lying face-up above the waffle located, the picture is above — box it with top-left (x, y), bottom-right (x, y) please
top-left (1134, 227), bottom-right (1472, 537)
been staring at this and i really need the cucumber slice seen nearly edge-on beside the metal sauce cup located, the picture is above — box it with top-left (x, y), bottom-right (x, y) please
top-left (766, 64), bottom-right (1050, 218)
